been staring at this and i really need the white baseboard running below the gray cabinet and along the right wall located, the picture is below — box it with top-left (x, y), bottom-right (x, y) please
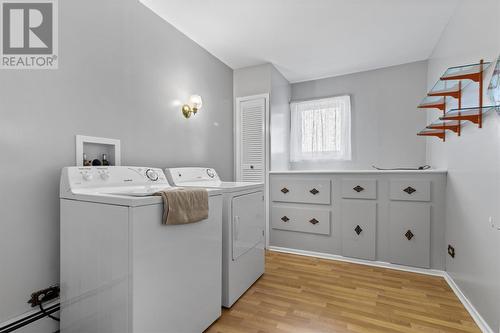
top-left (268, 246), bottom-right (494, 333)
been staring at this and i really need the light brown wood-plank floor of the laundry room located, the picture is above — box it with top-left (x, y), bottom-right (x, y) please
top-left (206, 252), bottom-right (480, 333)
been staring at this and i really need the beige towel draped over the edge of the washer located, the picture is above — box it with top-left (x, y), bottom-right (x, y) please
top-left (154, 188), bottom-right (208, 224)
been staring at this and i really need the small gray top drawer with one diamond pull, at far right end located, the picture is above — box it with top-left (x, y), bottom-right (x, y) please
top-left (390, 179), bottom-right (431, 201)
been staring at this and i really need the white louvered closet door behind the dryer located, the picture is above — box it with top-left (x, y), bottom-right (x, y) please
top-left (236, 97), bottom-right (266, 183)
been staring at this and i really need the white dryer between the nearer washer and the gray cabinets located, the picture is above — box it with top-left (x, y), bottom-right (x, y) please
top-left (165, 168), bottom-right (266, 307)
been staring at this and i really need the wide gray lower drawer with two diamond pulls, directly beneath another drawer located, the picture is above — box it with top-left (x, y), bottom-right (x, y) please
top-left (271, 206), bottom-right (330, 235)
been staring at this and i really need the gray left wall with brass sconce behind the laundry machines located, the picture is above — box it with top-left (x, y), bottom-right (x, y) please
top-left (0, 0), bottom-right (233, 322)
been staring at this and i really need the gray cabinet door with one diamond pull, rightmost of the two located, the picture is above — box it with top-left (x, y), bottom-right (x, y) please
top-left (389, 202), bottom-right (431, 268)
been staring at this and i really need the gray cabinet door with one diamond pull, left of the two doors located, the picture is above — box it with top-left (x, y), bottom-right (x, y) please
top-left (342, 200), bottom-right (377, 260)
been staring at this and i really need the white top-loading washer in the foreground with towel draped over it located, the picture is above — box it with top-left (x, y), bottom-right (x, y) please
top-left (60, 167), bottom-right (222, 333)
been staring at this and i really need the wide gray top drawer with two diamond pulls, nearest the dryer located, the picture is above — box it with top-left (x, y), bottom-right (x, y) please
top-left (271, 179), bottom-right (331, 205)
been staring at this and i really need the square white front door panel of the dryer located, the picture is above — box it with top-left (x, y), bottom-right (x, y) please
top-left (232, 192), bottom-right (266, 260)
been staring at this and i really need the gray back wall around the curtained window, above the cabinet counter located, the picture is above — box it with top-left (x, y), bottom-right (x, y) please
top-left (291, 61), bottom-right (427, 170)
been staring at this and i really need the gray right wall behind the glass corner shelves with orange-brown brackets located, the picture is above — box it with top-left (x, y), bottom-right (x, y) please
top-left (427, 0), bottom-right (500, 332)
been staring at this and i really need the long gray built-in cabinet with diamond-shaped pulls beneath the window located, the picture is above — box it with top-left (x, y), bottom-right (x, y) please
top-left (269, 170), bottom-right (446, 269)
